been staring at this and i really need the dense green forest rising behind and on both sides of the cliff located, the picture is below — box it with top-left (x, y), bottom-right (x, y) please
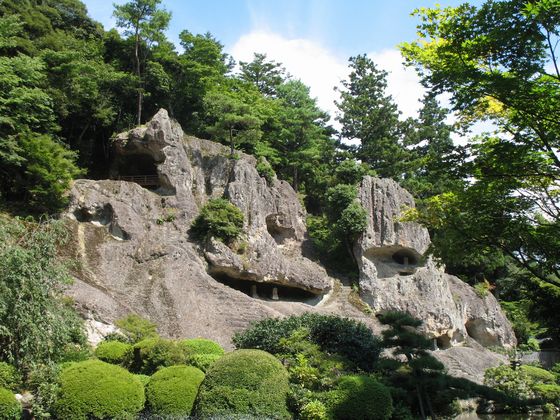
top-left (0, 0), bottom-right (560, 419)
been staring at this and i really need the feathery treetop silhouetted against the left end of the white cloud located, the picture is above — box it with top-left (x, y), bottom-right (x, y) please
top-left (239, 53), bottom-right (286, 96)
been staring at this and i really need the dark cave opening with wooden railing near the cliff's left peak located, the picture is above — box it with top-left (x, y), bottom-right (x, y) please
top-left (113, 154), bottom-right (161, 190)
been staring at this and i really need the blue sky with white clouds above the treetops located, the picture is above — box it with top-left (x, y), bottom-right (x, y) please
top-left (83, 0), bottom-right (482, 123)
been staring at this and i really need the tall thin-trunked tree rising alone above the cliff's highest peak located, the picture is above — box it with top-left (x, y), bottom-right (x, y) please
top-left (113, 0), bottom-right (171, 124)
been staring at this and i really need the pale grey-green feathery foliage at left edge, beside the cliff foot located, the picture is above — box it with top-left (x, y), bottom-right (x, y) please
top-left (0, 216), bottom-right (85, 373)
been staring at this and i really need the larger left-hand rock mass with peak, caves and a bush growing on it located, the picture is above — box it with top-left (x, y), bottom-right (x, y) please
top-left (66, 110), bottom-right (333, 346)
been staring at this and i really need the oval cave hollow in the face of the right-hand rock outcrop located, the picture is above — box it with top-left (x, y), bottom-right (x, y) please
top-left (365, 245), bottom-right (422, 278)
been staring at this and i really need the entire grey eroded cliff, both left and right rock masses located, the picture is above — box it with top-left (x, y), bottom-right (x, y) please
top-left (66, 110), bottom-right (514, 379)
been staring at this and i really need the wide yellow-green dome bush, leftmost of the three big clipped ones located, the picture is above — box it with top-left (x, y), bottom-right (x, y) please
top-left (54, 360), bottom-right (144, 420)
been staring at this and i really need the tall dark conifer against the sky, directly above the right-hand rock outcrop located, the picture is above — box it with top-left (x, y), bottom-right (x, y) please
top-left (336, 55), bottom-right (407, 180)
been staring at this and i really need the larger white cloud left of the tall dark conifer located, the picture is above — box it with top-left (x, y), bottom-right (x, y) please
top-left (230, 30), bottom-right (348, 121)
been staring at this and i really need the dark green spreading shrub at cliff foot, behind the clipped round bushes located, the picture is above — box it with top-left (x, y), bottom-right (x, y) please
top-left (233, 313), bottom-right (380, 370)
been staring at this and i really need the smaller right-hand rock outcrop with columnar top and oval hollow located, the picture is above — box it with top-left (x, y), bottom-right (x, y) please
top-left (354, 177), bottom-right (515, 349)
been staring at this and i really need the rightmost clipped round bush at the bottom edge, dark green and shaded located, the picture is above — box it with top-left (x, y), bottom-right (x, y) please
top-left (323, 375), bottom-right (393, 420)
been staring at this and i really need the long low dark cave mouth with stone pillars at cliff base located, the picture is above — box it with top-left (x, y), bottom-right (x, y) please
top-left (209, 272), bottom-right (321, 305)
